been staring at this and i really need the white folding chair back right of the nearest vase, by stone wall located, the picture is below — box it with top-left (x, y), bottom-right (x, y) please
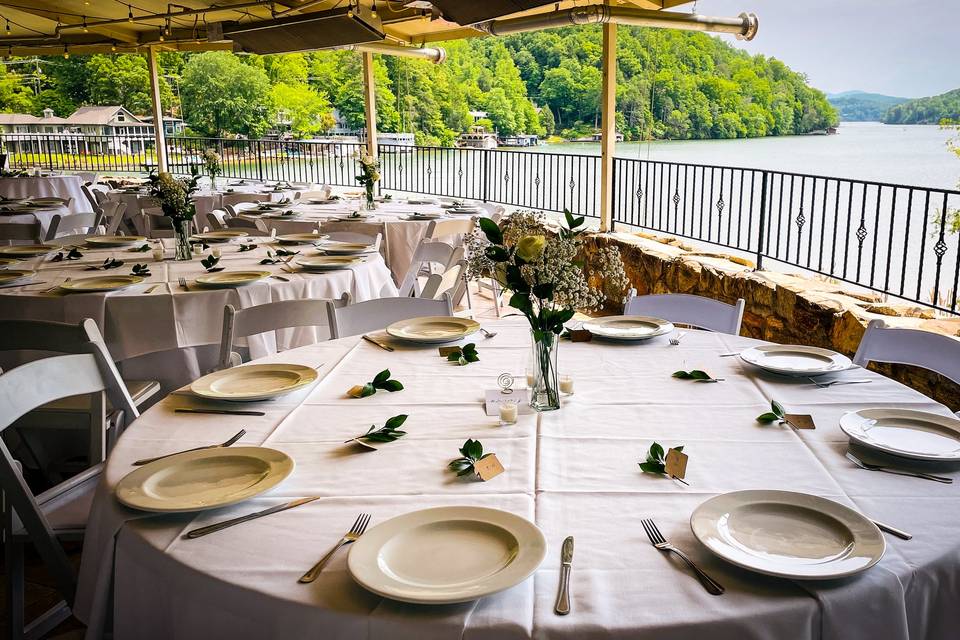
top-left (623, 289), bottom-right (744, 336)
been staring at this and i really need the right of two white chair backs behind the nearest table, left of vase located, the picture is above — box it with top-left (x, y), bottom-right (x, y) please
top-left (327, 296), bottom-right (453, 338)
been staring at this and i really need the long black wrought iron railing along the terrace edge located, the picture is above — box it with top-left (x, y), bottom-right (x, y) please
top-left (4, 134), bottom-right (960, 313)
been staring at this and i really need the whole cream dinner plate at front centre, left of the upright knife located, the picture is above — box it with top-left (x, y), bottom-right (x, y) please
top-left (347, 506), bottom-right (547, 604)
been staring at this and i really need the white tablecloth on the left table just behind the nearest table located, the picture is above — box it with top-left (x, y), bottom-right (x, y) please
top-left (0, 240), bottom-right (397, 389)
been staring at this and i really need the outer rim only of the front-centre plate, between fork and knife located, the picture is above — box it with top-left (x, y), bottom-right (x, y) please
top-left (347, 505), bottom-right (547, 604)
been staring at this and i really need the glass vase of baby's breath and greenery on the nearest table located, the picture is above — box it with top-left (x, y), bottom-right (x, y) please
top-left (467, 211), bottom-right (629, 411)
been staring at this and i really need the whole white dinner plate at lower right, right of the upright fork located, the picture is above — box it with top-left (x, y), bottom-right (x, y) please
top-left (690, 490), bottom-right (886, 580)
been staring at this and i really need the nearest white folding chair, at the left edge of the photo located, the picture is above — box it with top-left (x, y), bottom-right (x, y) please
top-left (0, 342), bottom-right (139, 638)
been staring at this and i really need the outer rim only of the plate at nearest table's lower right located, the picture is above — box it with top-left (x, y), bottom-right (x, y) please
top-left (690, 489), bottom-right (887, 580)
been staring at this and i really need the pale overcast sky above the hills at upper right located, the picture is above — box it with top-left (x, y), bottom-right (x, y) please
top-left (696, 0), bottom-right (960, 98)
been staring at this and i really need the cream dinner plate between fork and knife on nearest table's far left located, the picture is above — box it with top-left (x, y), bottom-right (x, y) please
top-left (116, 447), bottom-right (294, 513)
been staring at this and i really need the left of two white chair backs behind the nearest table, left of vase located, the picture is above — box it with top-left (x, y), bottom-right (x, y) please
top-left (218, 293), bottom-right (350, 369)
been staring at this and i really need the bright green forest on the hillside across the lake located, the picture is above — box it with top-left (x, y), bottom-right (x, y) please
top-left (0, 26), bottom-right (837, 145)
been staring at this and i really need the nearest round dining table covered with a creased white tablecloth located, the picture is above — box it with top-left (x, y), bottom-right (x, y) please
top-left (74, 318), bottom-right (960, 640)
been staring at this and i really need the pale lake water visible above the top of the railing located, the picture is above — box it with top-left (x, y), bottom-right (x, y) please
top-left (536, 122), bottom-right (960, 189)
